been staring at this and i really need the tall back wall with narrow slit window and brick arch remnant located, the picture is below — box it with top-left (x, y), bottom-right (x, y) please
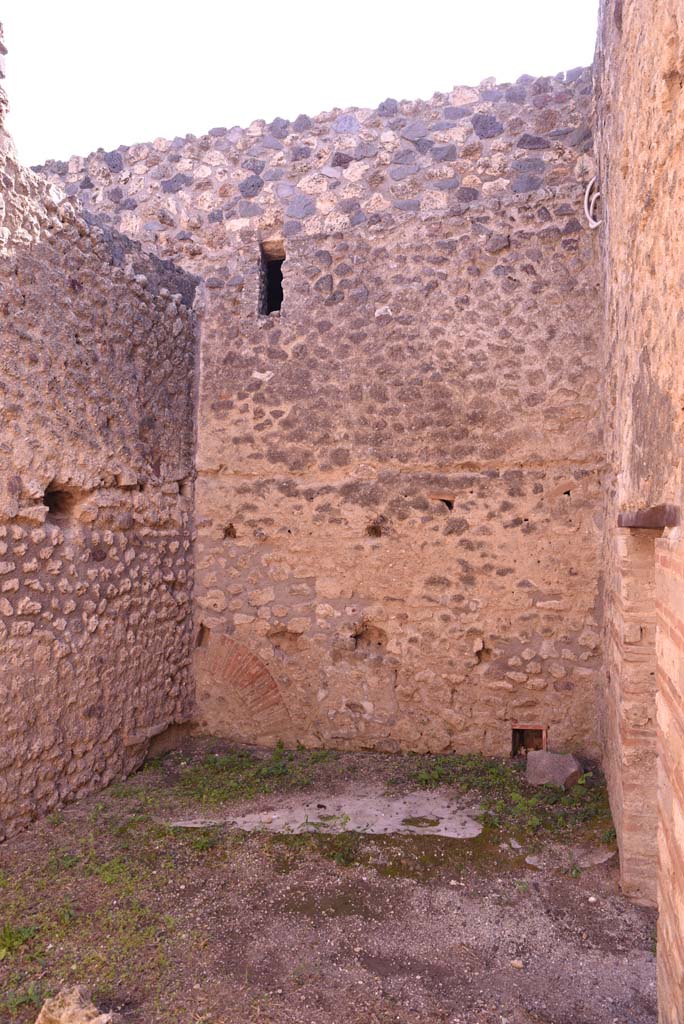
top-left (44, 70), bottom-right (601, 754)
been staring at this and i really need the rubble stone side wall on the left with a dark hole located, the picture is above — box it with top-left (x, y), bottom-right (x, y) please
top-left (0, 28), bottom-right (196, 839)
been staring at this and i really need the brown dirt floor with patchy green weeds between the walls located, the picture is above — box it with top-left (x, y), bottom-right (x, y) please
top-left (0, 740), bottom-right (656, 1024)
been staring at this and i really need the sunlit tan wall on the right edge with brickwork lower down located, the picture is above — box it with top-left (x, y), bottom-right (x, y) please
top-left (596, 0), bottom-right (684, 1007)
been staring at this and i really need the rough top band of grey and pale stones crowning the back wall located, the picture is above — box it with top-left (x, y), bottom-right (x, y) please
top-left (41, 69), bottom-right (593, 281)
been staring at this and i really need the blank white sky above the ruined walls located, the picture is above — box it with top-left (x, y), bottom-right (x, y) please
top-left (0, 0), bottom-right (598, 164)
